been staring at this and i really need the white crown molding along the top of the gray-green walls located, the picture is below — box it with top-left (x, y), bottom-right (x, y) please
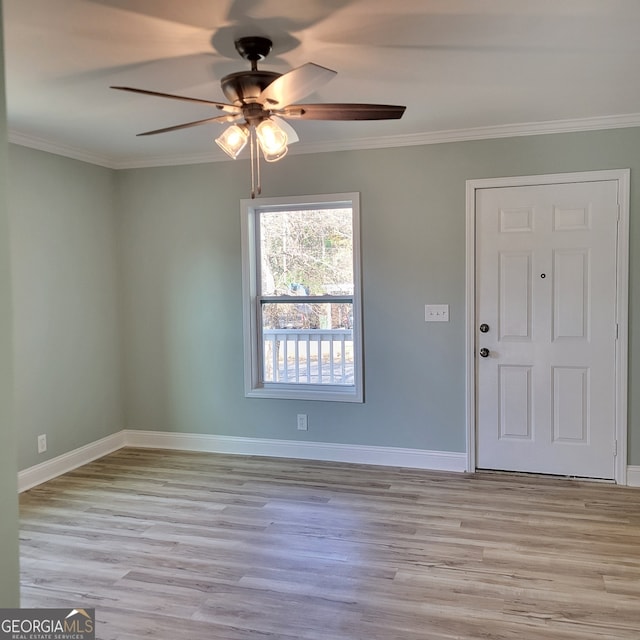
top-left (9, 113), bottom-right (640, 169)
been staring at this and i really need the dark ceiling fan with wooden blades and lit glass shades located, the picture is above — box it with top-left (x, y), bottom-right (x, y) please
top-left (111, 36), bottom-right (406, 198)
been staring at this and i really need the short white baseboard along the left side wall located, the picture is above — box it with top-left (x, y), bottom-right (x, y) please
top-left (18, 431), bottom-right (125, 492)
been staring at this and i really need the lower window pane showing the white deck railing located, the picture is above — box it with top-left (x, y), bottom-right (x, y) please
top-left (262, 302), bottom-right (354, 385)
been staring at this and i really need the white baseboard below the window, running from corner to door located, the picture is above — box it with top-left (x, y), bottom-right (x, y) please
top-left (124, 430), bottom-right (467, 472)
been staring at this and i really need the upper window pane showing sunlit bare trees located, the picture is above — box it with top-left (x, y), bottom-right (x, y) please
top-left (259, 208), bottom-right (353, 296)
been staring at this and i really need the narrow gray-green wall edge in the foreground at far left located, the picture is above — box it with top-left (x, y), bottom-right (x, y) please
top-left (0, 0), bottom-right (19, 607)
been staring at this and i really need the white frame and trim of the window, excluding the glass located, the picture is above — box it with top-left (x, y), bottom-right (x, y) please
top-left (240, 192), bottom-right (364, 402)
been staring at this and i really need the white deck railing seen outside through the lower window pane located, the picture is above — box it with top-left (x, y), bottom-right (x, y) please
top-left (262, 329), bottom-right (354, 385)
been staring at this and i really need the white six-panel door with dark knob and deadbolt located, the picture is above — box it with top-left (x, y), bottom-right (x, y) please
top-left (475, 180), bottom-right (618, 478)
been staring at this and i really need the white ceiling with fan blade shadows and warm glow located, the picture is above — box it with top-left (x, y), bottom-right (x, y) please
top-left (3, 0), bottom-right (640, 167)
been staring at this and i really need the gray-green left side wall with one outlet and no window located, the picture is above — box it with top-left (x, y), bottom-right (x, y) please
top-left (9, 145), bottom-right (124, 469)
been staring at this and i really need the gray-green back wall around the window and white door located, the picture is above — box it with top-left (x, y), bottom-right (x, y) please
top-left (118, 129), bottom-right (640, 464)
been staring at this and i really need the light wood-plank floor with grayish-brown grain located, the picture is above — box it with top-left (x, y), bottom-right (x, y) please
top-left (21, 449), bottom-right (640, 640)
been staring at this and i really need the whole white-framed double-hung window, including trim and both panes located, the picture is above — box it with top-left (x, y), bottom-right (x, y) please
top-left (242, 193), bottom-right (362, 402)
